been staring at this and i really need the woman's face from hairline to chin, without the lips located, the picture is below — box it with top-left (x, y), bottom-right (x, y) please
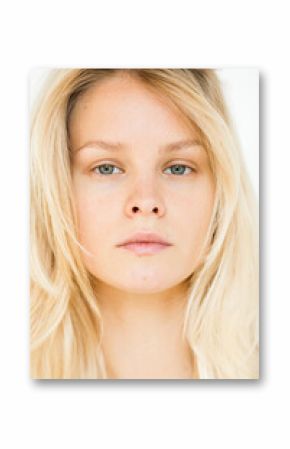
top-left (69, 74), bottom-right (214, 293)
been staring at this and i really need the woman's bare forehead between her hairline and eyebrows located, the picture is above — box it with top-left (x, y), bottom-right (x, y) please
top-left (69, 74), bottom-right (197, 146)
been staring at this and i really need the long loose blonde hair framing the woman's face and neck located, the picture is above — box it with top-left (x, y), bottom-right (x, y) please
top-left (30, 69), bottom-right (259, 379)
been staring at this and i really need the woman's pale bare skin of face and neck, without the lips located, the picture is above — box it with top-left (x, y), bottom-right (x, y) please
top-left (69, 74), bottom-right (215, 379)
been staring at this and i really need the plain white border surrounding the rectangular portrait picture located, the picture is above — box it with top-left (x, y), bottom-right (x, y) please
top-left (0, 0), bottom-right (290, 449)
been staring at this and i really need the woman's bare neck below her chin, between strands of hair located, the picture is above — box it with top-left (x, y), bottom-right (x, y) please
top-left (96, 284), bottom-right (197, 379)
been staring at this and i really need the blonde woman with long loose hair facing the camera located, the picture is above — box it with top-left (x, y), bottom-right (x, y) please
top-left (31, 69), bottom-right (259, 379)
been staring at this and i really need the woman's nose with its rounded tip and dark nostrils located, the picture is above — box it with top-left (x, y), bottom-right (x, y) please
top-left (126, 177), bottom-right (165, 218)
